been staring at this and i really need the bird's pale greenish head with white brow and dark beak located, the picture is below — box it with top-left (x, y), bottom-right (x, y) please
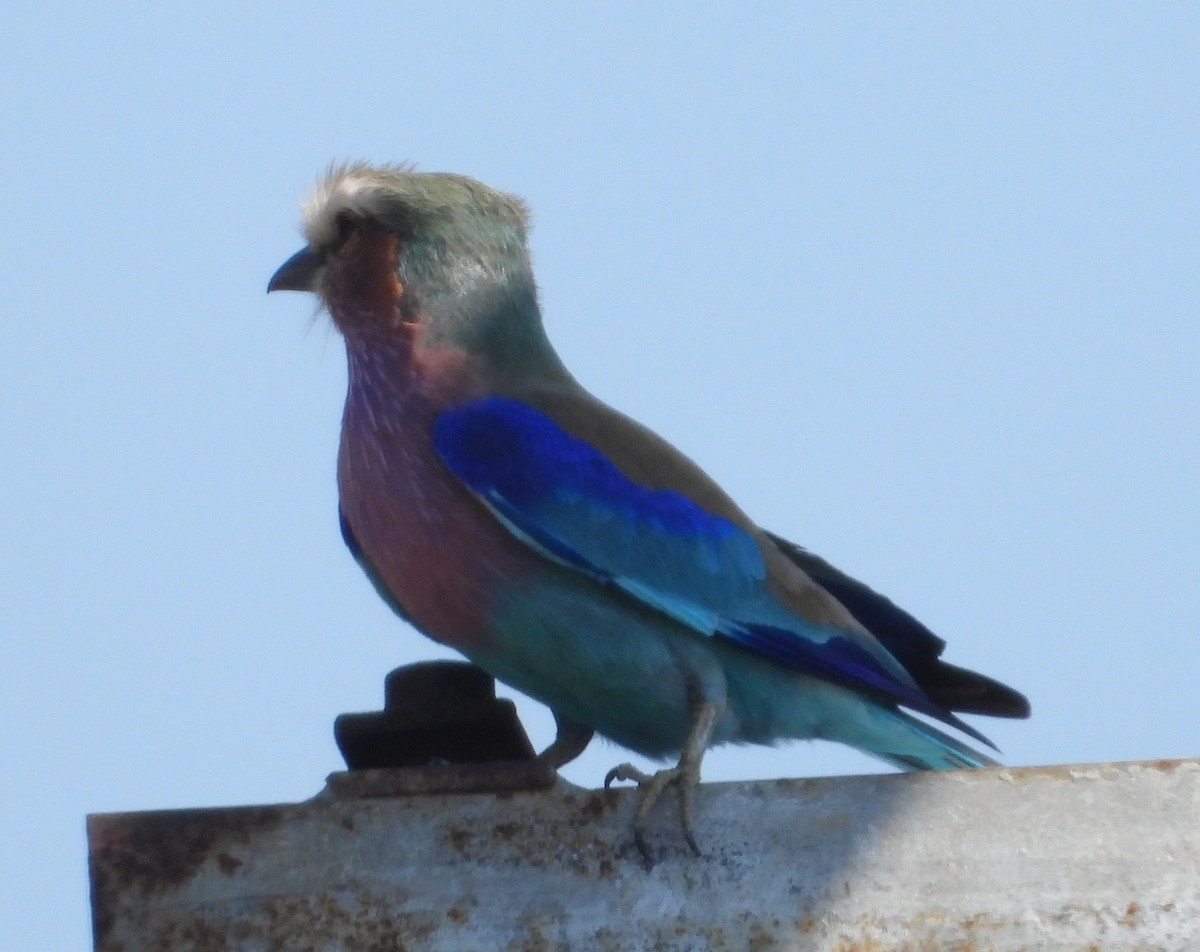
top-left (266, 163), bottom-right (548, 369)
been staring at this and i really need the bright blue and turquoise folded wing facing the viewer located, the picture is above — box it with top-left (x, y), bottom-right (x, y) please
top-left (433, 397), bottom-right (986, 742)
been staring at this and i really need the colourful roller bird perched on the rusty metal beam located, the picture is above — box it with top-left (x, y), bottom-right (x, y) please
top-left (268, 162), bottom-right (1030, 866)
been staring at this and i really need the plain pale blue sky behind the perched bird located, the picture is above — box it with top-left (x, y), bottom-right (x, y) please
top-left (0, 2), bottom-right (1200, 950)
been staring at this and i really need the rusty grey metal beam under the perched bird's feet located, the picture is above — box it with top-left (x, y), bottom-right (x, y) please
top-left (88, 760), bottom-right (1200, 952)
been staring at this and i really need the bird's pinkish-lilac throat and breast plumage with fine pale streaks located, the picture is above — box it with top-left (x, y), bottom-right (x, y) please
top-left (338, 339), bottom-right (538, 651)
